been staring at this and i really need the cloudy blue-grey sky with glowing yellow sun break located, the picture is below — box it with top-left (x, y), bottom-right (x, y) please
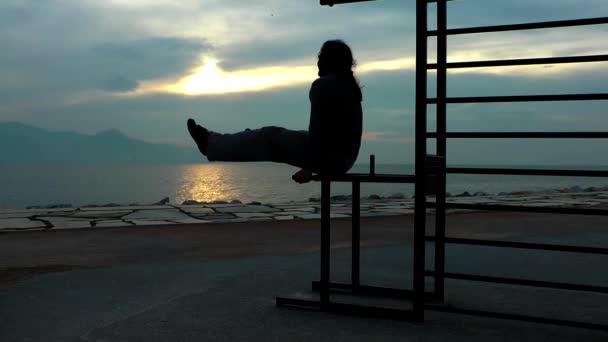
top-left (0, 0), bottom-right (608, 165)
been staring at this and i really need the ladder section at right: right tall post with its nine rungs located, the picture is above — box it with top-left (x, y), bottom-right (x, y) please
top-left (426, 0), bottom-right (608, 330)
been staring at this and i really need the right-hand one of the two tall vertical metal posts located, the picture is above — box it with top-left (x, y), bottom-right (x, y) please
top-left (434, 0), bottom-right (447, 300)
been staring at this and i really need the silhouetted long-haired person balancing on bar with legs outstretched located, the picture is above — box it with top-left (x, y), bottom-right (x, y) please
top-left (188, 40), bottom-right (363, 183)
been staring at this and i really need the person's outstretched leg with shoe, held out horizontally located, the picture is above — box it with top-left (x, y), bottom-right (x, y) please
top-left (188, 119), bottom-right (311, 168)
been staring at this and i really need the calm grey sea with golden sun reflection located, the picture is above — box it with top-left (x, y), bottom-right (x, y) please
top-left (0, 163), bottom-right (608, 209)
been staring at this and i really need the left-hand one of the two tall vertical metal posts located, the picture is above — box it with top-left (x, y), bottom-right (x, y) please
top-left (413, 0), bottom-right (428, 321)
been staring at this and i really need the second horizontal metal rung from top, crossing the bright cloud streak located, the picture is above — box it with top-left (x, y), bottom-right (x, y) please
top-left (427, 55), bottom-right (608, 70)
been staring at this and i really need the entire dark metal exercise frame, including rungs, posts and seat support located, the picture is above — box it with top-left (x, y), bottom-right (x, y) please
top-left (276, 0), bottom-right (608, 331)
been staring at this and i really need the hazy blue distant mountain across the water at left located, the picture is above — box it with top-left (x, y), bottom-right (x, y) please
top-left (0, 122), bottom-right (204, 163)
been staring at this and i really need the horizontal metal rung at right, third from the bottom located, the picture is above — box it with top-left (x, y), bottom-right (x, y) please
top-left (425, 236), bottom-right (608, 255)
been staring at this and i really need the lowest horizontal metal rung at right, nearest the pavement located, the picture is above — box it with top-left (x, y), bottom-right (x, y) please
top-left (424, 304), bottom-right (608, 331)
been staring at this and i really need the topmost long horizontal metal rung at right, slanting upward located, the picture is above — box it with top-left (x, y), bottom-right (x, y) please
top-left (427, 17), bottom-right (608, 37)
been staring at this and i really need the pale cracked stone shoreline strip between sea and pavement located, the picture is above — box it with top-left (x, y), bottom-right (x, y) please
top-left (0, 187), bottom-right (608, 232)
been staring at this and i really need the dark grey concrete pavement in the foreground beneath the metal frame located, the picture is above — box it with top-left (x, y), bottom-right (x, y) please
top-left (0, 214), bottom-right (608, 342)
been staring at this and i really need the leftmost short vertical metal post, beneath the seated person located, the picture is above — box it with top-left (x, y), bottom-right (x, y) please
top-left (320, 177), bottom-right (331, 311)
